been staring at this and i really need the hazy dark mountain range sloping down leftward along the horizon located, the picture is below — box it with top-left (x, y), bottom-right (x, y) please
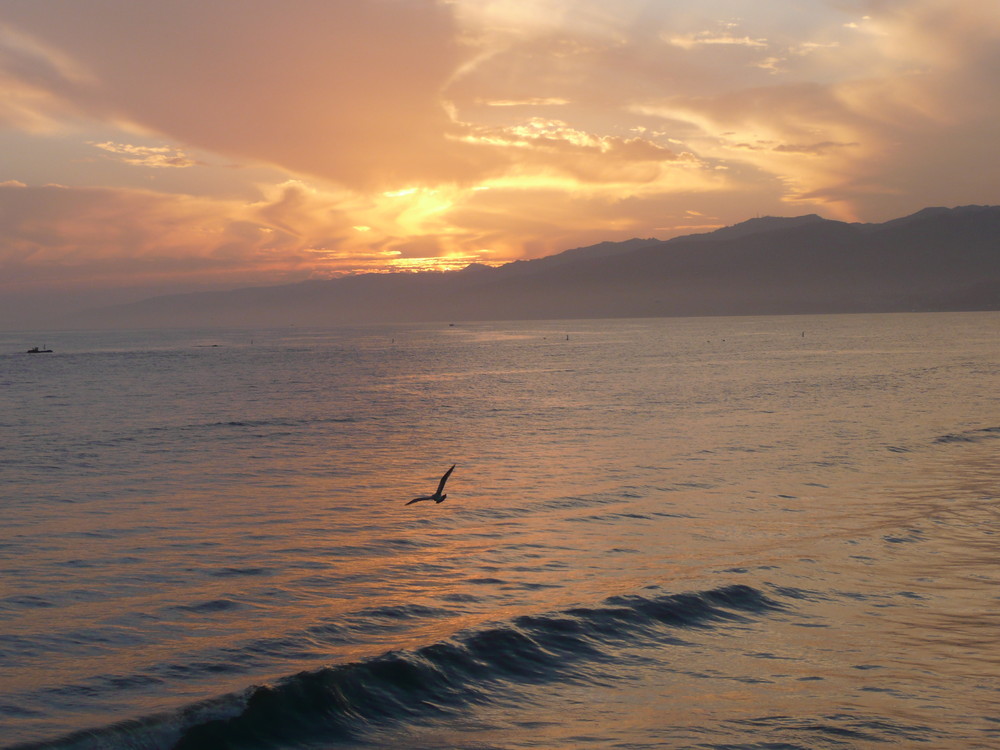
top-left (73, 206), bottom-right (1000, 328)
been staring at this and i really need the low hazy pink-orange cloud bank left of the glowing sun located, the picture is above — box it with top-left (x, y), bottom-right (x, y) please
top-left (0, 184), bottom-right (330, 288)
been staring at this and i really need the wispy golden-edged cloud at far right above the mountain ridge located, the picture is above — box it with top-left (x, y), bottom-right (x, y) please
top-left (636, 0), bottom-right (1000, 219)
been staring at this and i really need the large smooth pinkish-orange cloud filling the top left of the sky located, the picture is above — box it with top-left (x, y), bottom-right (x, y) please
top-left (4, 0), bottom-right (492, 186)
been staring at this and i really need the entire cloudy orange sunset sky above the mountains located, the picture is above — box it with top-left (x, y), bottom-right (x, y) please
top-left (0, 0), bottom-right (1000, 328)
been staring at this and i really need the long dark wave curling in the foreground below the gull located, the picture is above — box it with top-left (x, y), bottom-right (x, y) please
top-left (11, 585), bottom-right (781, 750)
